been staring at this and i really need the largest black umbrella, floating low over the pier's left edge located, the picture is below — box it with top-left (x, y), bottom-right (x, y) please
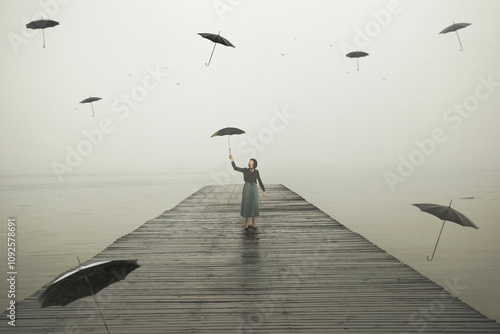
top-left (38, 259), bottom-right (140, 333)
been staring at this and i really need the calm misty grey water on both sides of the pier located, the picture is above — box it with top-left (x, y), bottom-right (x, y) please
top-left (0, 168), bottom-right (500, 321)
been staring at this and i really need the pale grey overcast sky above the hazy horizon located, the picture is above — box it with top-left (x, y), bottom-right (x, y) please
top-left (0, 0), bottom-right (500, 179)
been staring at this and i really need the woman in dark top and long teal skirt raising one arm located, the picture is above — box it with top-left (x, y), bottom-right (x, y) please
top-left (229, 154), bottom-right (266, 230)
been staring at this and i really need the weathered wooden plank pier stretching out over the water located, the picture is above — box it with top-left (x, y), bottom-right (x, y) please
top-left (6, 185), bottom-right (500, 334)
